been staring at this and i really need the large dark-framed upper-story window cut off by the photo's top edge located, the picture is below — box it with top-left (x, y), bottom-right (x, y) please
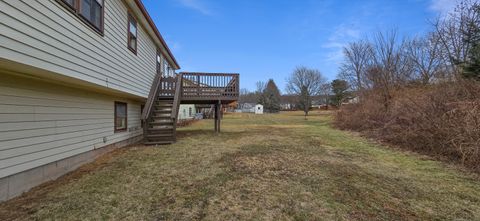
top-left (58, 0), bottom-right (104, 35)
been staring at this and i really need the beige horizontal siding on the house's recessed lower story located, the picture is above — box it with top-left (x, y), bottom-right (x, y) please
top-left (0, 71), bottom-right (143, 178)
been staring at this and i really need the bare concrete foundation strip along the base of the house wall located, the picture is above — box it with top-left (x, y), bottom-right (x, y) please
top-left (0, 136), bottom-right (143, 202)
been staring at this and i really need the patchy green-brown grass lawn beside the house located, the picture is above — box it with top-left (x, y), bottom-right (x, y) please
top-left (0, 112), bottom-right (480, 220)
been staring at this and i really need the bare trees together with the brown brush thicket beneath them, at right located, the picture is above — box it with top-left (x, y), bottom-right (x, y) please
top-left (335, 0), bottom-right (480, 171)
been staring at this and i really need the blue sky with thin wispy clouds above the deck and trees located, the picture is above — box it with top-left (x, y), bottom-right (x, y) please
top-left (143, 0), bottom-right (456, 91)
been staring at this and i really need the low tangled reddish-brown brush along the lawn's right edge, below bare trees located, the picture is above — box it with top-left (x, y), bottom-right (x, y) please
top-left (335, 82), bottom-right (480, 172)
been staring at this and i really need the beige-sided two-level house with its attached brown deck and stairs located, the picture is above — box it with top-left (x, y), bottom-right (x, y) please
top-left (0, 0), bottom-right (239, 201)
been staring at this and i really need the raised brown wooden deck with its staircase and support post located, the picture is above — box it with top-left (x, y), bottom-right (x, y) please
top-left (142, 72), bottom-right (240, 144)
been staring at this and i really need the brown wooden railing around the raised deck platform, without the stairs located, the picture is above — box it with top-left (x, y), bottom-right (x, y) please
top-left (180, 72), bottom-right (240, 100)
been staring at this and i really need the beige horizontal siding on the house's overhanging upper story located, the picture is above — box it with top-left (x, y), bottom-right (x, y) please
top-left (0, 0), bottom-right (161, 97)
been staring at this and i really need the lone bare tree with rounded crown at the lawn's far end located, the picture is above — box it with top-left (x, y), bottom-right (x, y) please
top-left (286, 66), bottom-right (327, 119)
